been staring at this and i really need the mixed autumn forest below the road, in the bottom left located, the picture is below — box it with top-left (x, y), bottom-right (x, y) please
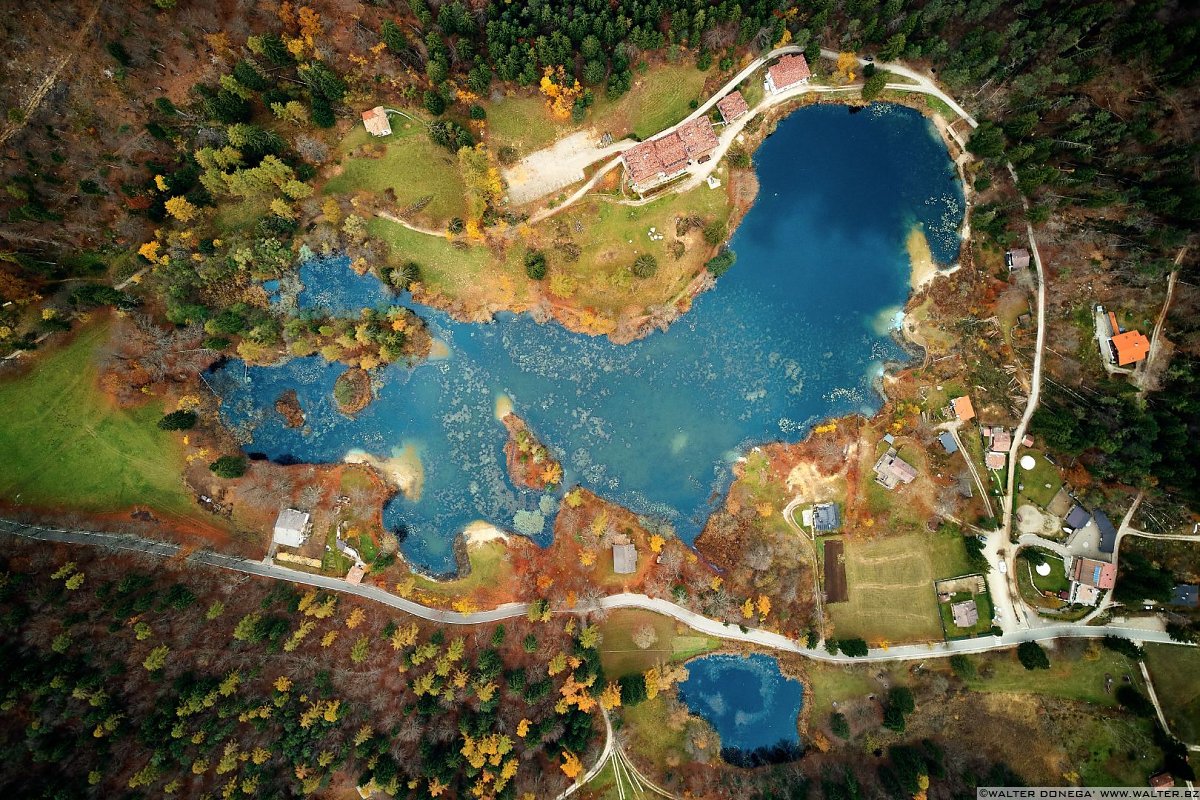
top-left (0, 541), bottom-right (604, 798)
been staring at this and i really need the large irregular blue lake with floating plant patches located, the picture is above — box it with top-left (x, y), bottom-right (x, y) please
top-left (212, 104), bottom-right (962, 572)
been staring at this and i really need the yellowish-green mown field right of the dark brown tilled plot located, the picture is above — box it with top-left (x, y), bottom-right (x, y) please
top-left (828, 533), bottom-right (970, 643)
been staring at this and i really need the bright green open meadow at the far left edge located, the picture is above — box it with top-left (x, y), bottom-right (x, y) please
top-left (0, 323), bottom-right (200, 524)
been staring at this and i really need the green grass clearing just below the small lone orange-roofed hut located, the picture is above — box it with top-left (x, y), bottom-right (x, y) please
top-left (322, 115), bottom-right (467, 227)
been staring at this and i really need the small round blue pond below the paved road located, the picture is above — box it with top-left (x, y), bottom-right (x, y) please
top-left (679, 655), bottom-right (804, 753)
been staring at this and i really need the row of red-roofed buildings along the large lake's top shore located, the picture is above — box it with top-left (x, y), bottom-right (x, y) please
top-left (622, 55), bottom-right (812, 194)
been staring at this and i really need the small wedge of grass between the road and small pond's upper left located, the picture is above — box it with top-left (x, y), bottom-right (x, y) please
top-left (600, 608), bottom-right (720, 678)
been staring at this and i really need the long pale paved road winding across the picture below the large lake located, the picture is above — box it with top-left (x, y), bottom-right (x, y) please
top-left (0, 521), bottom-right (1190, 663)
